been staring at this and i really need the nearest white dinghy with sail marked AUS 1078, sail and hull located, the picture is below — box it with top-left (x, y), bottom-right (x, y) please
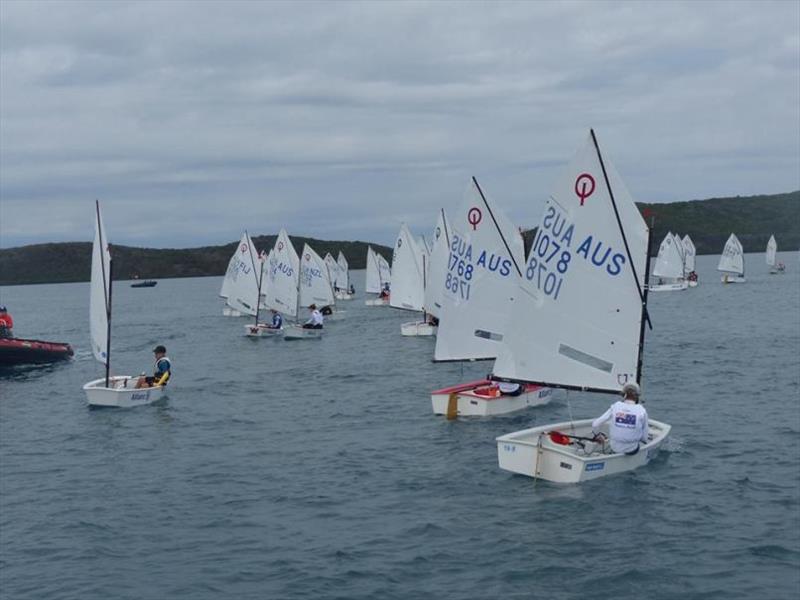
top-left (493, 131), bottom-right (670, 483)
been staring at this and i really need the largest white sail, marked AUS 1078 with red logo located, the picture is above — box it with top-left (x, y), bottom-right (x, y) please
top-left (494, 133), bottom-right (648, 392)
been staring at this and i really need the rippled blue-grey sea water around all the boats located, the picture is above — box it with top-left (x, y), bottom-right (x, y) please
top-left (0, 253), bottom-right (800, 600)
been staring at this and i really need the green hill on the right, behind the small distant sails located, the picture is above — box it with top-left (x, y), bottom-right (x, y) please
top-left (524, 191), bottom-right (800, 256)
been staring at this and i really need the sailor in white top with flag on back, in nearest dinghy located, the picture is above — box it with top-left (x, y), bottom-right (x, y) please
top-left (592, 381), bottom-right (648, 455)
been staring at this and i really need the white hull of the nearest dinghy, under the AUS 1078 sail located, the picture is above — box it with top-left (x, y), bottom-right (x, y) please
top-left (497, 419), bottom-right (671, 483)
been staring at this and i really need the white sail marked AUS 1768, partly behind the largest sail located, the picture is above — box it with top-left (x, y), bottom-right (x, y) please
top-left (434, 178), bottom-right (525, 360)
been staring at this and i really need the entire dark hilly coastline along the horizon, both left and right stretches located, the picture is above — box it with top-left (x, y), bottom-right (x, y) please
top-left (0, 191), bottom-right (800, 285)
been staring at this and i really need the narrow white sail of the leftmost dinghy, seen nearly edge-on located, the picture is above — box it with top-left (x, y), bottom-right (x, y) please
top-left (89, 202), bottom-right (111, 364)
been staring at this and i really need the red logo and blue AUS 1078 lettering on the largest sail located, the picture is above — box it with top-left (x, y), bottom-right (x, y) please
top-left (525, 173), bottom-right (627, 300)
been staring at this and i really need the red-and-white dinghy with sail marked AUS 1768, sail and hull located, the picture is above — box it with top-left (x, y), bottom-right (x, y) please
top-left (431, 177), bottom-right (551, 419)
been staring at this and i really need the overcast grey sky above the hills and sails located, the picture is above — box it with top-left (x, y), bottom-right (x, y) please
top-left (0, 0), bottom-right (800, 247)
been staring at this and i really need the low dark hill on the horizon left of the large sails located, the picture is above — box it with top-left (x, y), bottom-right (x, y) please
top-left (0, 235), bottom-right (392, 285)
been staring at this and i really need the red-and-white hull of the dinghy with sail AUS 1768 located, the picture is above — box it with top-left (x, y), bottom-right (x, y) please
top-left (431, 379), bottom-right (553, 419)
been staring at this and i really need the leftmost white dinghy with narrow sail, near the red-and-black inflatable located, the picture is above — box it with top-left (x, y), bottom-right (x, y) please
top-left (83, 201), bottom-right (166, 408)
